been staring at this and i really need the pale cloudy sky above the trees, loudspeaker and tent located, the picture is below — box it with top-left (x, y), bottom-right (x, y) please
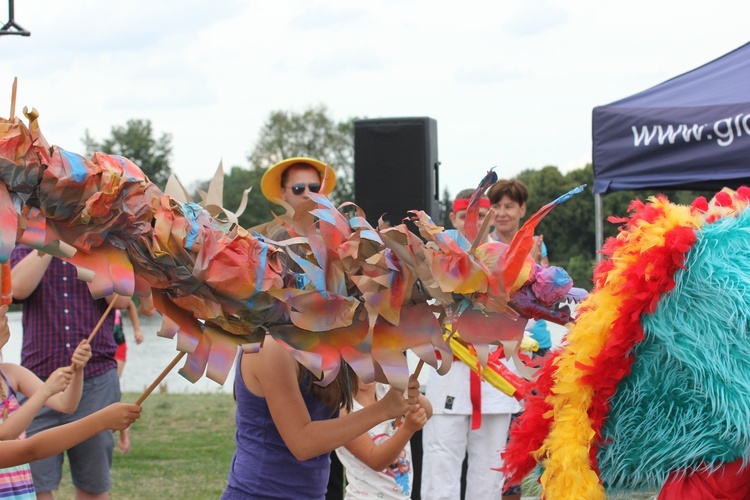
top-left (0, 0), bottom-right (750, 197)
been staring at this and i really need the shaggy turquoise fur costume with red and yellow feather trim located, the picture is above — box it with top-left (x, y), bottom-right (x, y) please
top-left (503, 187), bottom-right (750, 499)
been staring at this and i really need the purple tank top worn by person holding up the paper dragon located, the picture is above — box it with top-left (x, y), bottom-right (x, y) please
top-left (222, 354), bottom-right (335, 499)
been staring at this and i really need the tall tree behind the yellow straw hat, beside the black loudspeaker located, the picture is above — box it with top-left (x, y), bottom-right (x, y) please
top-left (248, 105), bottom-right (355, 202)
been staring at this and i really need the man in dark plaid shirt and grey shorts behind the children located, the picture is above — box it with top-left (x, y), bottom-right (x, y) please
top-left (11, 245), bottom-right (130, 500)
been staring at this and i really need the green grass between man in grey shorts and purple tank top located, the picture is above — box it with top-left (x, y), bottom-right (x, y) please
top-left (57, 393), bottom-right (235, 500)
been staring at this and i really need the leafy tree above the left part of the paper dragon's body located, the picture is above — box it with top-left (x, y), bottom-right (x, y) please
top-left (82, 119), bottom-right (172, 189)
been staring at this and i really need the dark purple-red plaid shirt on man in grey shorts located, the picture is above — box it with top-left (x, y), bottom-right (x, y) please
top-left (11, 245), bottom-right (117, 379)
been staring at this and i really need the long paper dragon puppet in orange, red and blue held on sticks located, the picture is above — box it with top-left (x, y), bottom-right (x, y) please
top-left (0, 106), bottom-right (570, 387)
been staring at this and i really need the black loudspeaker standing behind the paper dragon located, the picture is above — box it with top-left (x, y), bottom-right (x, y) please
top-left (354, 117), bottom-right (440, 226)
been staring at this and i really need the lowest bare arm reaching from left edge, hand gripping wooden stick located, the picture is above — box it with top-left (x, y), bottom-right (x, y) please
top-left (0, 403), bottom-right (141, 467)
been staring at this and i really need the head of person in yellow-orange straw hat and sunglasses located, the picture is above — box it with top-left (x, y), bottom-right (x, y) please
top-left (260, 156), bottom-right (336, 209)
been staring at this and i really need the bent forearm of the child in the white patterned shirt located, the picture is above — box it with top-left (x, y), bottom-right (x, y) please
top-left (344, 404), bottom-right (428, 471)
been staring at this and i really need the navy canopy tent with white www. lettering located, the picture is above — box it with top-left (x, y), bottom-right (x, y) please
top-left (593, 43), bottom-right (750, 254)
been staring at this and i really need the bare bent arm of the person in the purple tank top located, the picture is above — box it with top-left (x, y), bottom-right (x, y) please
top-left (248, 336), bottom-right (419, 461)
